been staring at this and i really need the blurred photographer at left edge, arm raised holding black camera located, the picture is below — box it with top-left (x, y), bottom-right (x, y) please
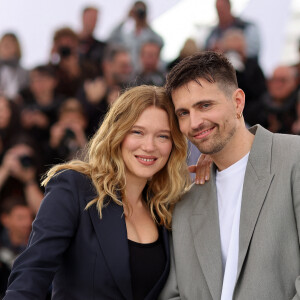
top-left (0, 136), bottom-right (43, 214)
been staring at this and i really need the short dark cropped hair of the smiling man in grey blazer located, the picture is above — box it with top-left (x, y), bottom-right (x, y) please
top-left (165, 51), bottom-right (238, 97)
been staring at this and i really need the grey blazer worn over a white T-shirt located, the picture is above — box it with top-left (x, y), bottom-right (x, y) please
top-left (160, 126), bottom-right (300, 300)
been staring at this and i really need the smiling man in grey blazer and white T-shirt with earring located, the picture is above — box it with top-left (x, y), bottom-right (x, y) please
top-left (161, 52), bottom-right (300, 300)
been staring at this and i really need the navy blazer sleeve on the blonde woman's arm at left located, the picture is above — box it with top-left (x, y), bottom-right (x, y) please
top-left (4, 171), bottom-right (80, 300)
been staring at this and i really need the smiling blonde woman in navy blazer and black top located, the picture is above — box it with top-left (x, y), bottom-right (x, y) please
top-left (4, 86), bottom-right (189, 300)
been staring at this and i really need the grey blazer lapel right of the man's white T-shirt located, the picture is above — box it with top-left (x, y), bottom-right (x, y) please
top-left (237, 126), bottom-right (274, 280)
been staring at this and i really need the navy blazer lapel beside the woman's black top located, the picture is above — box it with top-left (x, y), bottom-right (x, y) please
top-left (88, 200), bottom-right (132, 300)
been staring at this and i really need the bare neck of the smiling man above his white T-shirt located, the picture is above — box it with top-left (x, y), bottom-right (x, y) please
top-left (211, 127), bottom-right (254, 171)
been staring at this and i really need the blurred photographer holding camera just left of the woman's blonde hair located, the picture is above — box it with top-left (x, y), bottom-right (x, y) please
top-left (49, 98), bottom-right (87, 163)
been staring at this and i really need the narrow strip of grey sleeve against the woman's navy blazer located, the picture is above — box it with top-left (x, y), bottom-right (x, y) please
top-left (158, 234), bottom-right (181, 300)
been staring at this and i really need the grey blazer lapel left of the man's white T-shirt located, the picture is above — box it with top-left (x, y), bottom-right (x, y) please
top-left (190, 168), bottom-right (223, 300)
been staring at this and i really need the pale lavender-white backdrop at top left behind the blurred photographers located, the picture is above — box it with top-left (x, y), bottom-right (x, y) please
top-left (0, 0), bottom-right (180, 67)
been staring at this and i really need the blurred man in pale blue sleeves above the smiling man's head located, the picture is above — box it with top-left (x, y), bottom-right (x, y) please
top-left (205, 0), bottom-right (260, 58)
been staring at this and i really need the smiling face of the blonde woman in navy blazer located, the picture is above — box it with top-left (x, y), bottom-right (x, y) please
top-left (121, 106), bottom-right (172, 182)
